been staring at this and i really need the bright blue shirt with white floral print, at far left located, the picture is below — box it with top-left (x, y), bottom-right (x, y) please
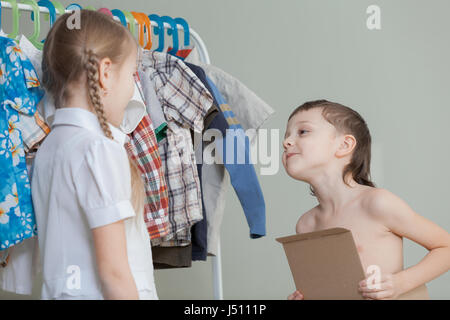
top-left (0, 37), bottom-right (44, 250)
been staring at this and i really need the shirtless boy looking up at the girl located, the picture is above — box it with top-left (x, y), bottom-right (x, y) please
top-left (283, 100), bottom-right (450, 300)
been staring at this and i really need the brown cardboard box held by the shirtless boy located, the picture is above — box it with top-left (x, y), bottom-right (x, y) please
top-left (276, 228), bottom-right (428, 300)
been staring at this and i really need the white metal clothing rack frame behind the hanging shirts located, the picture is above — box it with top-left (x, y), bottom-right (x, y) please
top-left (0, 1), bottom-right (223, 300)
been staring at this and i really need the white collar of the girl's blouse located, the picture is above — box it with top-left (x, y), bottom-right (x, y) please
top-left (52, 108), bottom-right (127, 146)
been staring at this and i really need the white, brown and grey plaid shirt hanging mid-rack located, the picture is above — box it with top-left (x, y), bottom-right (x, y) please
top-left (140, 50), bottom-right (213, 246)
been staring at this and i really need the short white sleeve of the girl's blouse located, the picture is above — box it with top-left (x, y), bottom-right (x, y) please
top-left (74, 140), bottom-right (135, 229)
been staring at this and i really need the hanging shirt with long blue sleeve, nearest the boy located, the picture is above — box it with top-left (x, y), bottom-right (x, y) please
top-left (203, 78), bottom-right (266, 252)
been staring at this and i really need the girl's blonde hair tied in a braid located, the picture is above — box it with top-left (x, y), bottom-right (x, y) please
top-left (42, 10), bottom-right (145, 218)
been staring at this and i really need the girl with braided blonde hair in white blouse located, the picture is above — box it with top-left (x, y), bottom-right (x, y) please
top-left (32, 10), bottom-right (158, 299)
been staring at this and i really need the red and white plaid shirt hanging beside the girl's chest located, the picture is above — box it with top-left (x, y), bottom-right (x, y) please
top-left (125, 79), bottom-right (169, 239)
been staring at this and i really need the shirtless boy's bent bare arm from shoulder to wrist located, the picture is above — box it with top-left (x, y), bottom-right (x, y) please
top-left (370, 189), bottom-right (450, 295)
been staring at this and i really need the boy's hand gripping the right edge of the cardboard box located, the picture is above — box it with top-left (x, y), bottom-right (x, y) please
top-left (358, 274), bottom-right (400, 300)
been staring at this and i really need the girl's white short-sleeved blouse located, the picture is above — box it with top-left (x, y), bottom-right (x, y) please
top-left (31, 108), bottom-right (158, 299)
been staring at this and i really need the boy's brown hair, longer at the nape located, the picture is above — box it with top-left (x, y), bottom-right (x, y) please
top-left (288, 100), bottom-right (375, 187)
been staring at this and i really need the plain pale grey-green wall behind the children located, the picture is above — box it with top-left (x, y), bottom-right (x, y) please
top-left (0, 0), bottom-right (450, 299)
